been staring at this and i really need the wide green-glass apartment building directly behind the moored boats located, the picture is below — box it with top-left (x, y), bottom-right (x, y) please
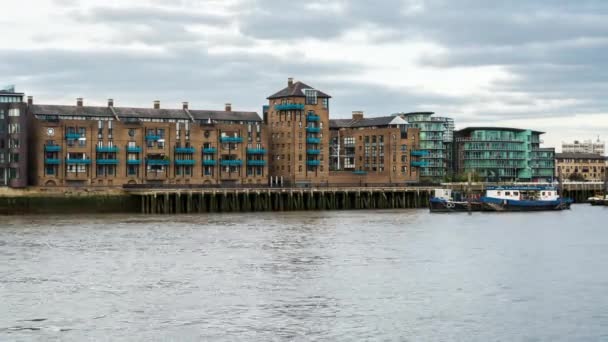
top-left (455, 127), bottom-right (555, 182)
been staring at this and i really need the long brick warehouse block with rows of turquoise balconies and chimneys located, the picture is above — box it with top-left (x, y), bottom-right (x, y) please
top-left (28, 98), bottom-right (268, 186)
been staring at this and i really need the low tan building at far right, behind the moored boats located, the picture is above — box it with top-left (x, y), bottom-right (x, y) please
top-left (555, 153), bottom-right (606, 181)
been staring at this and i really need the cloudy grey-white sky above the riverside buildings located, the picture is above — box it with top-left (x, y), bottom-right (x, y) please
top-left (0, 0), bottom-right (608, 150)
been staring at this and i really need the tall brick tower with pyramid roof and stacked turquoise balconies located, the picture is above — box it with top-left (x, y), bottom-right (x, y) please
top-left (265, 78), bottom-right (331, 186)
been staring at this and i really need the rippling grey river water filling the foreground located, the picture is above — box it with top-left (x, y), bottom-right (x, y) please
top-left (0, 205), bottom-right (608, 341)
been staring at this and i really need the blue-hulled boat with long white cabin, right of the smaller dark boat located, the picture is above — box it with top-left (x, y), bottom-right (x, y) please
top-left (480, 186), bottom-right (572, 211)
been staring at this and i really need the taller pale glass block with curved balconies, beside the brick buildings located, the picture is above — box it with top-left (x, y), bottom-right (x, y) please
top-left (394, 112), bottom-right (454, 182)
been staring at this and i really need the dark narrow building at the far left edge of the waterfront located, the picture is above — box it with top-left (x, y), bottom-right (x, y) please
top-left (0, 87), bottom-right (28, 188)
